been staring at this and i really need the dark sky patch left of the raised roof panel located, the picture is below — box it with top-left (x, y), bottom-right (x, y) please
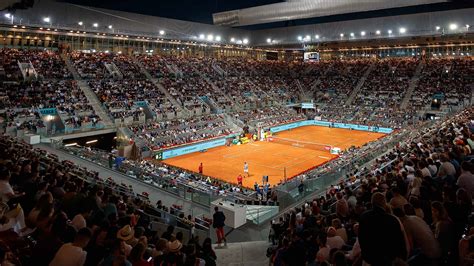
top-left (64, 0), bottom-right (284, 24)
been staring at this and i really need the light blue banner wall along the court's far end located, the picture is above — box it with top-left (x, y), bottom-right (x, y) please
top-left (270, 120), bottom-right (393, 134)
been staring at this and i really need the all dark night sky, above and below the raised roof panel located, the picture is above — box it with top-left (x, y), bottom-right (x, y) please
top-left (62, 0), bottom-right (474, 30)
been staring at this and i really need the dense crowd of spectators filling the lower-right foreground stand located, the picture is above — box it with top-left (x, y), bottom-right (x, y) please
top-left (269, 108), bottom-right (474, 266)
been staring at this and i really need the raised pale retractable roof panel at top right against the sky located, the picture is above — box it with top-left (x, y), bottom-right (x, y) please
top-left (213, 0), bottom-right (474, 28)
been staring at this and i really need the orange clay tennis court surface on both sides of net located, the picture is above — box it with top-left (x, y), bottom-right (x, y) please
top-left (164, 126), bottom-right (385, 188)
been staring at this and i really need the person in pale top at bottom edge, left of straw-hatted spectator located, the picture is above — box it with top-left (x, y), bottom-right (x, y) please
top-left (49, 228), bottom-right (92, 266)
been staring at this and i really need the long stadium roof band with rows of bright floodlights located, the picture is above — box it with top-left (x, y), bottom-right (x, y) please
top-left (4, 0), bottom-right (474, 48)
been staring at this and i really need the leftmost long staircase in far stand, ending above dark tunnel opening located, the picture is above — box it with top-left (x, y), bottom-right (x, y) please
top-left (61, 53), bottom-right (114, 128)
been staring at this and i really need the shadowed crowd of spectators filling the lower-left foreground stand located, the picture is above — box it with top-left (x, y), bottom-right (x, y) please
top-left (0, 136), bottom-right (216, 266)
